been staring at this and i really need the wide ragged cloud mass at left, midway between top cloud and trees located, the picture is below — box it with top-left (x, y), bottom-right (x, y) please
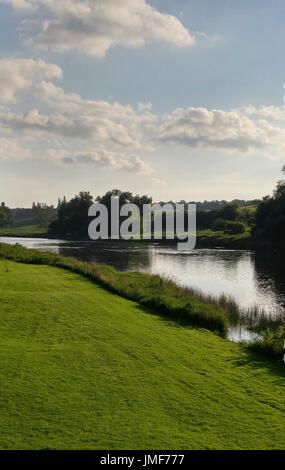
top-left (0, 70), bottom-right (156, 174)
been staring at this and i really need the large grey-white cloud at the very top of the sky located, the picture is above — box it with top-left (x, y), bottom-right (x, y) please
top-left (0, 0), bottom-right (195, 57)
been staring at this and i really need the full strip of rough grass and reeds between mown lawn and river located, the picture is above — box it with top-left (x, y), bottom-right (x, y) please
top-left (0, 243), bottom-right (285, 360)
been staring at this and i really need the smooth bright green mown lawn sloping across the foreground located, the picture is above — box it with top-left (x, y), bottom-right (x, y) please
top-left (0, 261), bottom-right (285, 449)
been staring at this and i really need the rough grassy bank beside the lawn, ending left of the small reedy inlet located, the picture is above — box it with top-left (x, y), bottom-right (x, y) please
top-left (0, 244), bottom-right (228, 336)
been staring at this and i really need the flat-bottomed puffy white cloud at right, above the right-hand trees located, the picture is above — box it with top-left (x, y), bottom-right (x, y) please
top-left (158, 107), bottom-right (285, 152)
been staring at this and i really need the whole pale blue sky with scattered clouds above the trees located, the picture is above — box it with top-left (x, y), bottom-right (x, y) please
top-left (0, 0), bottom-right (285, 207)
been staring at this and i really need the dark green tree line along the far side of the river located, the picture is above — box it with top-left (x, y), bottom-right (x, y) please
top-left (0, 166), bottom-right (285, 250)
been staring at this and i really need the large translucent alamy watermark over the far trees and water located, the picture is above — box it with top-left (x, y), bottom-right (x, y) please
top-left (88, 197), bottom-right (196, 251)
